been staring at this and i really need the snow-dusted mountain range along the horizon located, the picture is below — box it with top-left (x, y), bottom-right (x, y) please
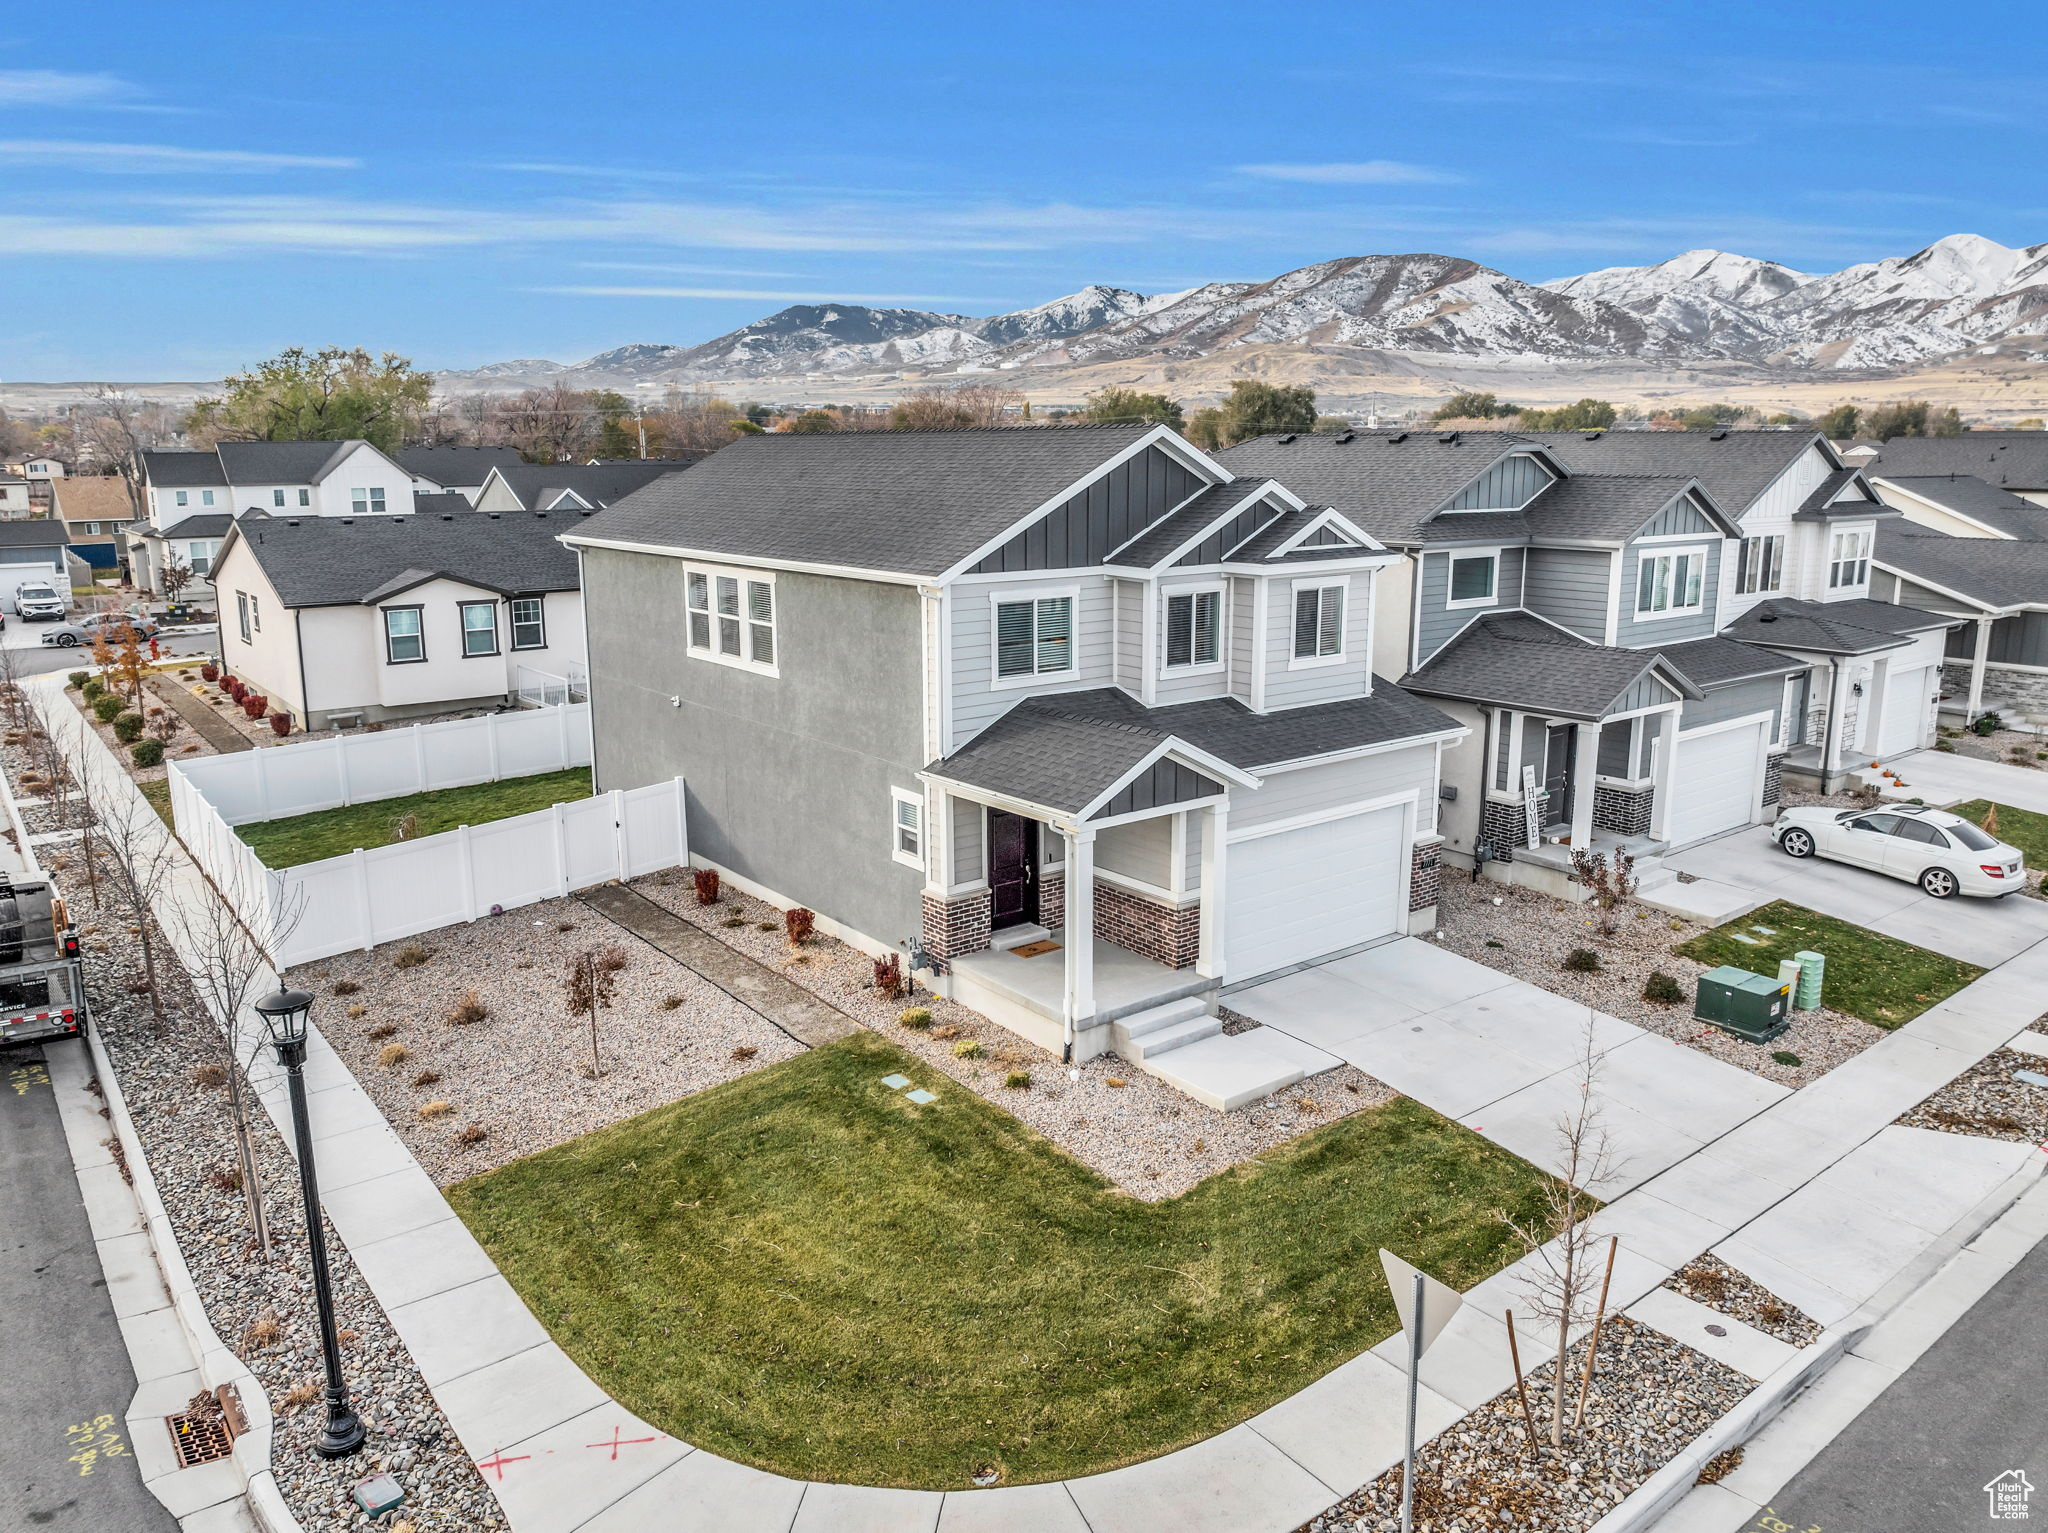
top-left (440, 233), bottom-right (2048, 387)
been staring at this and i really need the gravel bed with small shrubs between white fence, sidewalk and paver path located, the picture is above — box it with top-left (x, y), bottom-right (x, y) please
top-left (291, 899), bottom-right (803, 1187)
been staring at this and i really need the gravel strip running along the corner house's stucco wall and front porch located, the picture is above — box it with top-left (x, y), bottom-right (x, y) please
top-left (633, 872), bottom-right (1395, 1201)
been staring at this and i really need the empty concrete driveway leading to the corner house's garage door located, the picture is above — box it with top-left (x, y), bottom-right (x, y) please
top-left (1225, 937), bottom-right (1790, 1197)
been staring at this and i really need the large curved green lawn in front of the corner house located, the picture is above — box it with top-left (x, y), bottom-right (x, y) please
top-left (449, 1034), bottom-right (1542, 1488)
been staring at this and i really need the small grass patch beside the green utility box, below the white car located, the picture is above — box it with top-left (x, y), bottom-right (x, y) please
top-left (1671, 896), bottom-right (1974, 1027)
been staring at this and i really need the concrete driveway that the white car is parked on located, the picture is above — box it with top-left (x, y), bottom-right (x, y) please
top-left (1665, 826), bottom-right (2048, 968)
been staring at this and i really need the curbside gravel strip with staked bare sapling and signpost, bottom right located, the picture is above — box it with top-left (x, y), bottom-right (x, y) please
top-left (1298, 1316), bottom-right (1753, 1533)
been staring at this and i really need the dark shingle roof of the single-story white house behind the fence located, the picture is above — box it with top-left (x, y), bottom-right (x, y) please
top-left (236, 512), bottom-right (584, 606)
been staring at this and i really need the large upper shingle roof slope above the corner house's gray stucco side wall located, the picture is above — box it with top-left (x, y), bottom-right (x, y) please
top-left (584, 426), bottom-right (1153, 575)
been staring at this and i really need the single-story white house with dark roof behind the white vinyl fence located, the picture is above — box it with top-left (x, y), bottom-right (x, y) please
top-left (213, 512), bottom-right (589, 729)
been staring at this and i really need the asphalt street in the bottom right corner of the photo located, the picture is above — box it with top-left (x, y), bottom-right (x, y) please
top-left (1741, 1244), bottom-right (2048, 1533)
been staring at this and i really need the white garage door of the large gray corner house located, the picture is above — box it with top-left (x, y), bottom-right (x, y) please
top-left (1223, 804), bottom-right (1403, 980)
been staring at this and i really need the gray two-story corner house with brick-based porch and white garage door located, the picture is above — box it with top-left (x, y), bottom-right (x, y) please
top-left (565, 426), bottom-right (1466, 1105)
